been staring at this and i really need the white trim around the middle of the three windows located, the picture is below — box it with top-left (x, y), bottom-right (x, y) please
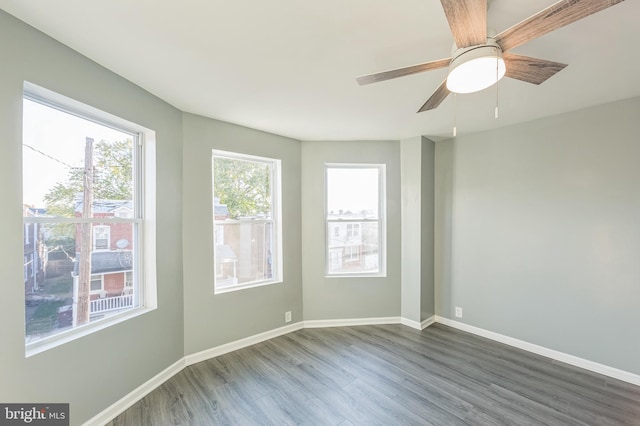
top-left (209, 149), bottom-right (284, 294)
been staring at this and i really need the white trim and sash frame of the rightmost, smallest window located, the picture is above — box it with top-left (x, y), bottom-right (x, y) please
top-left (324, 163), bottom-right (387, 278)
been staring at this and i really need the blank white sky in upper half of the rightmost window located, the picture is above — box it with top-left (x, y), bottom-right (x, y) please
top-left (327, 168), bottom-right (379, 213)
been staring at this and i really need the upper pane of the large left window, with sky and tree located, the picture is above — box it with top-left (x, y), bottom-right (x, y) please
top-left (22, 99), bottom-right (133, 217)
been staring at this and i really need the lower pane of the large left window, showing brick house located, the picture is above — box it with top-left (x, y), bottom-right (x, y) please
top-left (24, 223), bottom-right (139, 343)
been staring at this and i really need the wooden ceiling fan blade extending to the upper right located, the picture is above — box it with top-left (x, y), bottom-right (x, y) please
top-left (495, 0), bottom-right (624, 51)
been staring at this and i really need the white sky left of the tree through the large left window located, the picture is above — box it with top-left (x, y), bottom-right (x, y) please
top-left (22, 99), bottom-right (131, 207)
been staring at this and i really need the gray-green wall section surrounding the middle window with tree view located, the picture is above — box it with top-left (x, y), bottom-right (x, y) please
top-left (183, 113), bottom-right (302, 355)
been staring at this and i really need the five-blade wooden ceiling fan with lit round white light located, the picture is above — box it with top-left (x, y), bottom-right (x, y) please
top-left (356, 0), bottom-right (624, 112)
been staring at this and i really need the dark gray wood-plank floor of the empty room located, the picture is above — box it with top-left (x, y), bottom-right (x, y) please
top-left (109, 324), bottom-right (640, 426)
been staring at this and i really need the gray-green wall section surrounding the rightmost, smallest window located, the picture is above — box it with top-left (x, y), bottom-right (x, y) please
top-left (302, 141), bottom-right (400, 320)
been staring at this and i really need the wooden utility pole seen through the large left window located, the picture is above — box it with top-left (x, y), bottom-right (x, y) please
top-left (76, 138), bottom-right (93, 325)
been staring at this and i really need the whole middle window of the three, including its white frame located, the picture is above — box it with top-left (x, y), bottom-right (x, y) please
top-left (212, 150), bottom-right (282, 293)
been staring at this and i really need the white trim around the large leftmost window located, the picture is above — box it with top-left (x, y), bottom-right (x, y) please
top-left (23, 81), bottom-right (157, 358)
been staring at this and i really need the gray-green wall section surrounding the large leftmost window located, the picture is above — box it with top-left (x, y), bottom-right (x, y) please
top-left (0, 11), bottom-right (183, 424)
